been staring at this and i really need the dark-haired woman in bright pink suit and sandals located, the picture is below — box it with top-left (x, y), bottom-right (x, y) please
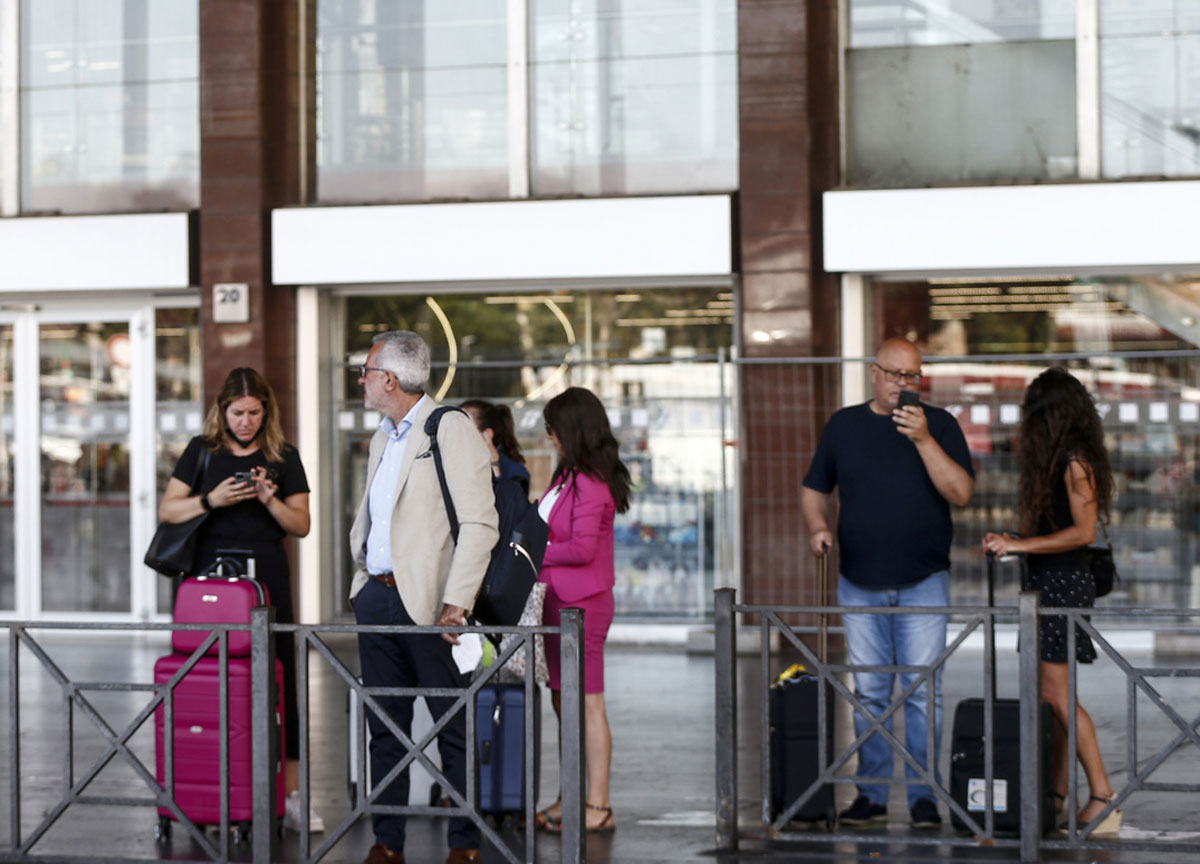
top-left (538, 388), bottom-right (629, 832)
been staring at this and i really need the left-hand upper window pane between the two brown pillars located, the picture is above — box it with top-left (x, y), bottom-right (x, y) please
top-left (317, 0), bottom-right (509, 202)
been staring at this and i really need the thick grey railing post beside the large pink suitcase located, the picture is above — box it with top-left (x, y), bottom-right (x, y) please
top-left (250, 606), bottom-right (282, 864)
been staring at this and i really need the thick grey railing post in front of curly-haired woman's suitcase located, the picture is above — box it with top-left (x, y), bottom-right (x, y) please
top-left (1018, 592), bottom-right (1043, 864)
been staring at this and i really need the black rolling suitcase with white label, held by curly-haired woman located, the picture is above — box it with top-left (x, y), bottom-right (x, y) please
top-left (950, 553), bottom-right (1055, 833)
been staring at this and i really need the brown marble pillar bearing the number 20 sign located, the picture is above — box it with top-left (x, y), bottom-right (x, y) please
top-left (198, 0), bottom-right (314, 438)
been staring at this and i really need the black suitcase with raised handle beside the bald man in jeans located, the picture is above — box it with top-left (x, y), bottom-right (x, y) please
top-left (767, 553), bottom-right (836, 827)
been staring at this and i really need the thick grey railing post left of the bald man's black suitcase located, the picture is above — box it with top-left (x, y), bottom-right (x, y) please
top-left (713, 588), bottom-right (738, 851)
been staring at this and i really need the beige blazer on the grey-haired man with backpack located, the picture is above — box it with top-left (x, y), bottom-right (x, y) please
top-left (350, 398), bottom-right (499, 625)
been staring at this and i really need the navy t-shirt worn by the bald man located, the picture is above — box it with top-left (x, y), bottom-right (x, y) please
top-left (804, 403), bottom-right (974, 588)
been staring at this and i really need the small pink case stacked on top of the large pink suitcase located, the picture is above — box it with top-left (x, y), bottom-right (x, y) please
top-left (170, 575), bottom-right (271, 658)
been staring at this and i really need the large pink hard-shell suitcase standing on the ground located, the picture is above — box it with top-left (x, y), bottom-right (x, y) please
top-left (154, 654), bottom-right (287, 830)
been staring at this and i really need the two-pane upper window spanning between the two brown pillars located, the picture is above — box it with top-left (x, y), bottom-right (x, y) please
top-left (317, 0), bottom-right (738, 203)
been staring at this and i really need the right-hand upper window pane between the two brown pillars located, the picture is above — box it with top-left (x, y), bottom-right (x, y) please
top-left (530, 0), bottom-right (737, 194)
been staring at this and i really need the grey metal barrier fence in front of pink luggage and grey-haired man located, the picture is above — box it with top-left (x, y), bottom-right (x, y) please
top-left (0, 607), bottom-right (584, 864)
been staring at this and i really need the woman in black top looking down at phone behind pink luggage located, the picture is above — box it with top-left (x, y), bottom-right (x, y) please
top-left (158, 367), bottom-right (319, 829)
